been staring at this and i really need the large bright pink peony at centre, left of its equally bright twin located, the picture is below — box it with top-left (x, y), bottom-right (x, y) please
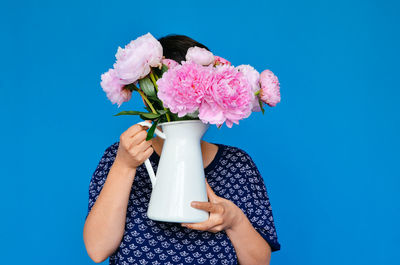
top-left (156, 61), bottom-right (213, 117)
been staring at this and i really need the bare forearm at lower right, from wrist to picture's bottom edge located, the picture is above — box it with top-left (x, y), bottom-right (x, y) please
top-left (225, 208), bottom-right (271, 265)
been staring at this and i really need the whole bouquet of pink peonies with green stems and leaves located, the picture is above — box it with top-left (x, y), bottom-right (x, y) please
top-left (101, 33), bottom-right (280, 139)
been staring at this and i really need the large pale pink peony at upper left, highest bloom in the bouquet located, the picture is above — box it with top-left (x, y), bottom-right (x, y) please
top-left (114, 32), bottom-right (163, 84)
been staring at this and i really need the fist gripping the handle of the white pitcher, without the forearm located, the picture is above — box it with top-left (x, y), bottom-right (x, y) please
top-left (115, 124), bottom-right (154, 169)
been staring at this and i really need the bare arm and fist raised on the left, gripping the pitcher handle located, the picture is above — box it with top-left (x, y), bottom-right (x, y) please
top-left (83, 124), bottom-right (153, 263)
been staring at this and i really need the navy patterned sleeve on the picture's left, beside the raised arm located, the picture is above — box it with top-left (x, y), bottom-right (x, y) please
top-left (85, 142), bottom-right (118, 219)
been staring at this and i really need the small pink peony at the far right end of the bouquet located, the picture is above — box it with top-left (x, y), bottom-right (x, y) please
top-left (260, 70), bottom-right (281, 107)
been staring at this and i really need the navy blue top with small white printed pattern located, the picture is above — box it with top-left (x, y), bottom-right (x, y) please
top-left (86, 142), bottom-right (280, 265)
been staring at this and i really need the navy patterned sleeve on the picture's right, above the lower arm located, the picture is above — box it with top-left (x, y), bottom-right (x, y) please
top-left (238, 151), bottom-right (281, 251)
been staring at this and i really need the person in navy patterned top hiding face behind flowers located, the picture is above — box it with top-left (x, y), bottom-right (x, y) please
top-left (83, 35), bottom-right (280, 265)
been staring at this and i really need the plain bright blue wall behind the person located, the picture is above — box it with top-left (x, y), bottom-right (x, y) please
top-left (0, 0), bottom-right (400, 265)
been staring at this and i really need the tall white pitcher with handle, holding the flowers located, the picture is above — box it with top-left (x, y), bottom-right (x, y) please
top-left (138, 120), bottom-right (209, 223)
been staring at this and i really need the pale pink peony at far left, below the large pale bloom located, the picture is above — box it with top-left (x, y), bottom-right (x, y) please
top-left (100, 69), bottom-right (132, 108)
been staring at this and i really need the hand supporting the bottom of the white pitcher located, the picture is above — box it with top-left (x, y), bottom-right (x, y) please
top-left (182, 177), bottom-right (244, 233)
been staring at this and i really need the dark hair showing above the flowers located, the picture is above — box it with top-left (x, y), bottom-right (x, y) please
top-left (158, 34), bottom-right (210, 63)
